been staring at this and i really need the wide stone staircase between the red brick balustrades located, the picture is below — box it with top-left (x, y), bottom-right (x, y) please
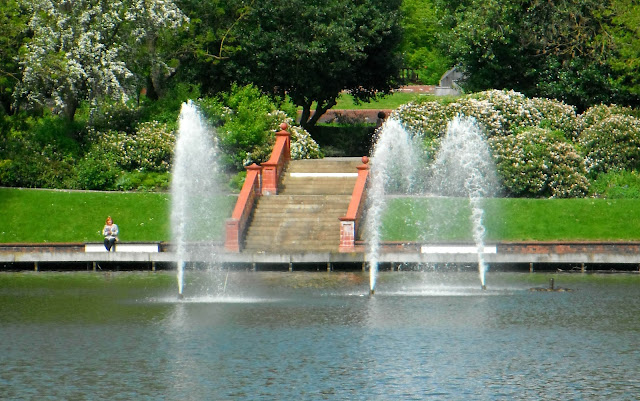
top-left (243, 157), bottom-right (362, 253)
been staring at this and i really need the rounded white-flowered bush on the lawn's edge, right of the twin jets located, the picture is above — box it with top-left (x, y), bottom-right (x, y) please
top-left (489, 127), bottom-right (589, 198)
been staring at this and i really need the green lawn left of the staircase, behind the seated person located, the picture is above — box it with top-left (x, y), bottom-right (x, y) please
top-left (0, 188), bottom-right (235, 243)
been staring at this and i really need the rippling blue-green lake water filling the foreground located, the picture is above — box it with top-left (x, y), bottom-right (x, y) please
top-left (0, 272), bottom-right (640, 400)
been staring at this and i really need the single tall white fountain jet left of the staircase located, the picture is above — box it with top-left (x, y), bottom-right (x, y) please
top-left (171, 101), bottom-right (218, 298)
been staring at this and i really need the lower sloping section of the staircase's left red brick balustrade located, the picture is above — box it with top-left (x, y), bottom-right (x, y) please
top-left (224, 163), bottom-right (262, 252)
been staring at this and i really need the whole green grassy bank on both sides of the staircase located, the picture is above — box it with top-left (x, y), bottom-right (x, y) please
top-left (0, 188), bottom-right (640, 243)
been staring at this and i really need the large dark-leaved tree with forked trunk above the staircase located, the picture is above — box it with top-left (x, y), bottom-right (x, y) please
top-left (230, 0), bottom-right (401, 128)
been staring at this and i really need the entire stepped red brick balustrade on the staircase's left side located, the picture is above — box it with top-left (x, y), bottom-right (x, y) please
top-left (224, 123), bottom-right (291, 252)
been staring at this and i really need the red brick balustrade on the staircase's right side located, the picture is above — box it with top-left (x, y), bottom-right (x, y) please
top-left (339, 156), bottom-right (369, 252)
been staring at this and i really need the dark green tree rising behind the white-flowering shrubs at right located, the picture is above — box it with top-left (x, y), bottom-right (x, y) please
top-left (438, 0), bottom-right (617, 109)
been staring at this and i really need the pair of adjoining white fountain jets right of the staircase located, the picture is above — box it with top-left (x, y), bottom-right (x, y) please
top-left (365, 117), bottom-right (498, 294)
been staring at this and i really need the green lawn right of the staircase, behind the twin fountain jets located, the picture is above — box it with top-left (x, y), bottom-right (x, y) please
top-left (382, 198), bottom-right (640, 241)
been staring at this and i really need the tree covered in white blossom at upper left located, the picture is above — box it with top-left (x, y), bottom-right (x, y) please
top-left (17, 0), bottom-right (186, 120)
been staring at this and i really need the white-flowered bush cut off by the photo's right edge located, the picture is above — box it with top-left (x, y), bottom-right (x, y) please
top-left (580, 114), bottom-right (640, 176)
